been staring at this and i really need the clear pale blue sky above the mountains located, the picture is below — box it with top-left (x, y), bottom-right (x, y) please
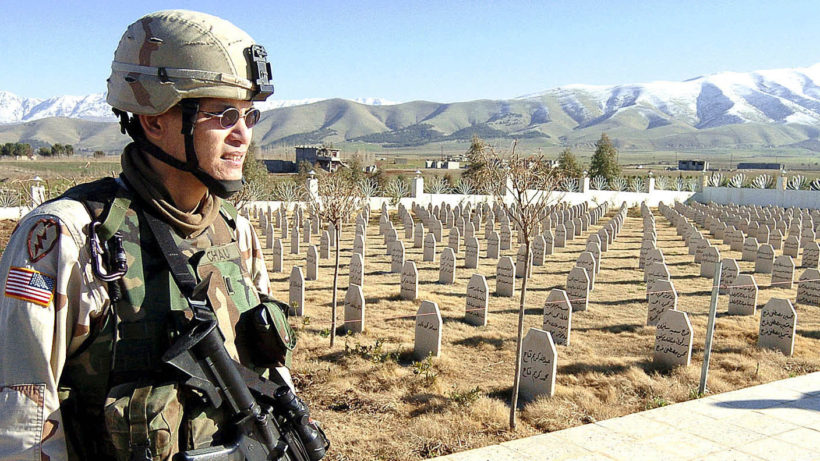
top-left (0, 0), bottom-right (820, 102)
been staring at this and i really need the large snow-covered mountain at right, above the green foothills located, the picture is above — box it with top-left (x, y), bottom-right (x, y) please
top-left (516, 64), bottom-right (820, 129)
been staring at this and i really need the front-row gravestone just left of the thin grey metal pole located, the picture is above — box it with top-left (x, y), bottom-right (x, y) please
top-left (653, 310), bottom-right (693, 369)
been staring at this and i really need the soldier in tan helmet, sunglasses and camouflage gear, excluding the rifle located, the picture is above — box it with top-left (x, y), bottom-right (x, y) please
top-left (0, 10), bottom-right (314, 461)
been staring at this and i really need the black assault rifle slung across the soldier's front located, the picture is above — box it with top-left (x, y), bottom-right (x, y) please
top-left (162, 292), bottom-right (330, 461)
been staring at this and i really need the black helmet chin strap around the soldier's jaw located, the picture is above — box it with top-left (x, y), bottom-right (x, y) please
top-left (140, 99), bottom-right (245, 199)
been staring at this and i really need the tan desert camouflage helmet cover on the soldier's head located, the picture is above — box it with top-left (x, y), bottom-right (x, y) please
top-left (107, 10), bottom-right (273, 115)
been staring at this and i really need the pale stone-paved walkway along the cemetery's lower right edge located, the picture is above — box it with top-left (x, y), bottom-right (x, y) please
top-left (434, 372), bottom-right (820, 461)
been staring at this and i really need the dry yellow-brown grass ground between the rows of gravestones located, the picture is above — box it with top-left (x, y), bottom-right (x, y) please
top-left (265, 207), bottom-right (820, 460)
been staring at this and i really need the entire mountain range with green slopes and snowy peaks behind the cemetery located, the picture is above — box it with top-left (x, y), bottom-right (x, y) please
top-left (0, 64), bottom-right (820, 150)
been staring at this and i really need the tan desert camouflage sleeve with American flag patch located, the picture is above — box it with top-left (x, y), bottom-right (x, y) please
top-left (0, 200), bottom-right (107, 461)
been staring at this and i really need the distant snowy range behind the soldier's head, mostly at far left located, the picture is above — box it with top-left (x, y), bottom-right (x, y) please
top-left (0, 90), bottom-right (395, 123)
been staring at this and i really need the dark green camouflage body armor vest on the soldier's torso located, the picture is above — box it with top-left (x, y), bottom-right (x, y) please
top-left (60, 178), bottom-right (260, 459)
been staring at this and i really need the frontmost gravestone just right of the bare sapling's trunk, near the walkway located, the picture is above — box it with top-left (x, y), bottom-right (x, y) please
top-left (519, 328), bottom-right (558, 400)
